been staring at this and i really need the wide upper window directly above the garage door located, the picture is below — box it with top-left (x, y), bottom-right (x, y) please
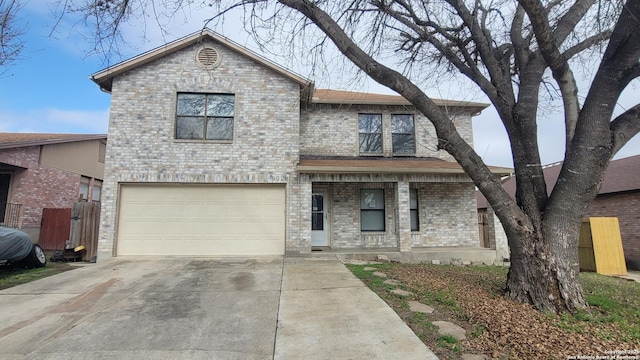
top-left (176, 93), bottom-right (235, 140)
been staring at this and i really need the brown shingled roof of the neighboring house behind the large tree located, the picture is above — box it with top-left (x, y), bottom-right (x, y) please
top-left (476, 155), bottom-right (640, 209)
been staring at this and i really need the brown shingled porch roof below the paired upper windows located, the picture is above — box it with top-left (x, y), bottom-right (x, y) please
top-left (298, 156), bottom-right (513, 175)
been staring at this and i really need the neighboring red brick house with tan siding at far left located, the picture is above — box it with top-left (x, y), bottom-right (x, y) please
top-left (0, 133), bottom-right (107, 242)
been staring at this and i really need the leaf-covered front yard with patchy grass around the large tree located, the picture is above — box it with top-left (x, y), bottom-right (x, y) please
top-left (349, 264), bottom-right (640, 359)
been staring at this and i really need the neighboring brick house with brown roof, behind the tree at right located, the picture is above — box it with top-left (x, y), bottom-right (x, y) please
top-left (477, 155), bottom-right (640, 270)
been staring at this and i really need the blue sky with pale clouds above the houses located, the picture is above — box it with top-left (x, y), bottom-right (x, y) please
top-left (0, 0), bottom-right (640, 166)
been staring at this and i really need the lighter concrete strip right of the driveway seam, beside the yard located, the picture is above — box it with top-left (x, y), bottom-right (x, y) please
top-left (274, 258), bottom-right (437, 360)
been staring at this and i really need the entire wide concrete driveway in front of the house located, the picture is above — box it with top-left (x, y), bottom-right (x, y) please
top-left (0, 257), bottom-right (437, 360)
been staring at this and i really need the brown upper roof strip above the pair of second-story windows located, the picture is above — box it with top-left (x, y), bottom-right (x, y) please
top-left (311, 89), bottom-right (489, 113)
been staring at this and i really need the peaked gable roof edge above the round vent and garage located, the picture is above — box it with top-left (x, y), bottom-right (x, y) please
top-left (91, 29), bottom-right (313, 97)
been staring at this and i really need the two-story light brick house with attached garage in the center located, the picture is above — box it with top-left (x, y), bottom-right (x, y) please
top-left (92, 30), bottom-right (510, 261)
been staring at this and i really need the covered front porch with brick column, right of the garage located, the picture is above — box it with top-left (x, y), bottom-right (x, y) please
top-left (297, 157), bottom-right (510, 263)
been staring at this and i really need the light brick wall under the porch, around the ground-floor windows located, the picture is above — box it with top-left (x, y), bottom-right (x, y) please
top-left (312, 174), bottom-right (480, 249)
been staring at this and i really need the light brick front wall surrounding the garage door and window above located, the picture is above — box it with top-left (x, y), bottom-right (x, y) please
top-left (98, 40), bottom-right (300, 257)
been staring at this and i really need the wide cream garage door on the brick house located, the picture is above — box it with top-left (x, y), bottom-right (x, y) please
top-left (117, 185), bottom-right (285, 256)
